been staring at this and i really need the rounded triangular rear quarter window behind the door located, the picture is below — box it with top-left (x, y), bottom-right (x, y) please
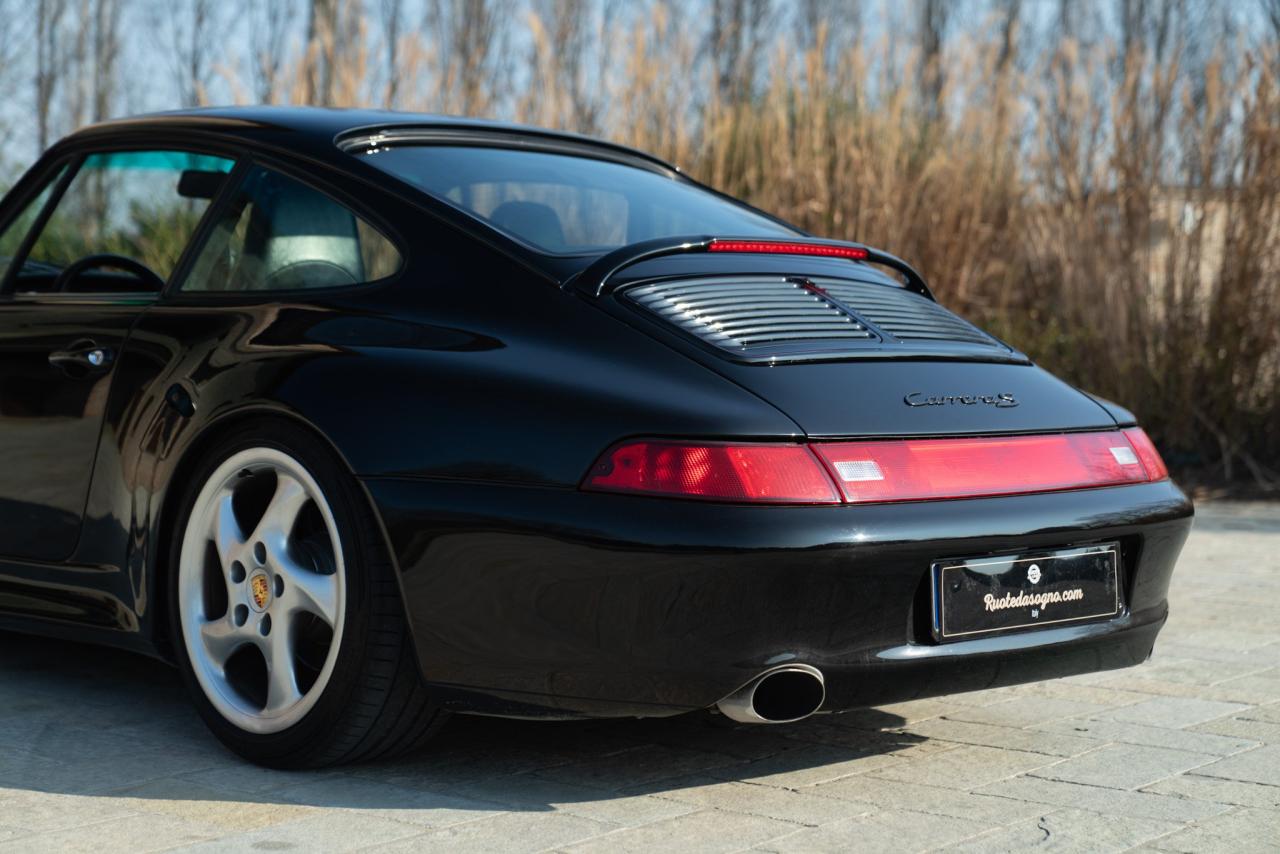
top-left (182, 166), bottom-right (402, 292)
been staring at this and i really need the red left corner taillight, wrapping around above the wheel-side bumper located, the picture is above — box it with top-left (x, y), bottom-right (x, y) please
top-left (582, 442), bottom-right (840, 504)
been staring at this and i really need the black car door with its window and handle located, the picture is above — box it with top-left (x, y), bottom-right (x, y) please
top-left (0, 150), bottom-right (234, 562)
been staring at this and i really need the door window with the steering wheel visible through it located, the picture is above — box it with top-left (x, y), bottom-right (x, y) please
top-left (18, 151), bottom-right (234, 293)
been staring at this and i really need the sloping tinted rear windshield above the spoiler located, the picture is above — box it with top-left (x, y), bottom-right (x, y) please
top-left (361, 146), bottom-right (796, 255)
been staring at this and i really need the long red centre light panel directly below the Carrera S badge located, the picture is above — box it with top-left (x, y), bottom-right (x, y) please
top-left (813, 431), bottom-right (1148, 503)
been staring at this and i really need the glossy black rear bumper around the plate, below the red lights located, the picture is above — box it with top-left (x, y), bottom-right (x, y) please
top-left (365, 479), bottom-right (1193, 717)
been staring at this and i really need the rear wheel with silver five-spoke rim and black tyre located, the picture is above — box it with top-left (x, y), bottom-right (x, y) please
top-left (170, 421), bottom-right (444, 768)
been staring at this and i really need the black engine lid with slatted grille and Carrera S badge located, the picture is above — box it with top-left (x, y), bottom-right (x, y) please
top-left (593, 256), bottom-right (1116, 438)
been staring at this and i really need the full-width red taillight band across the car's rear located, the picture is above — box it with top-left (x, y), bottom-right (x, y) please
top-left (582, 428), bottom-right (1169, 504)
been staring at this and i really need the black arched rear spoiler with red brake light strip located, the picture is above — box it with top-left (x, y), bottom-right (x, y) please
top-left (566, 237), bottom-right (937, 302)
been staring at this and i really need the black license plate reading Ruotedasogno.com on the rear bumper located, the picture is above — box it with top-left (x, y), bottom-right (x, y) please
top-left (933, 543), bottom-right (1120, 640)
